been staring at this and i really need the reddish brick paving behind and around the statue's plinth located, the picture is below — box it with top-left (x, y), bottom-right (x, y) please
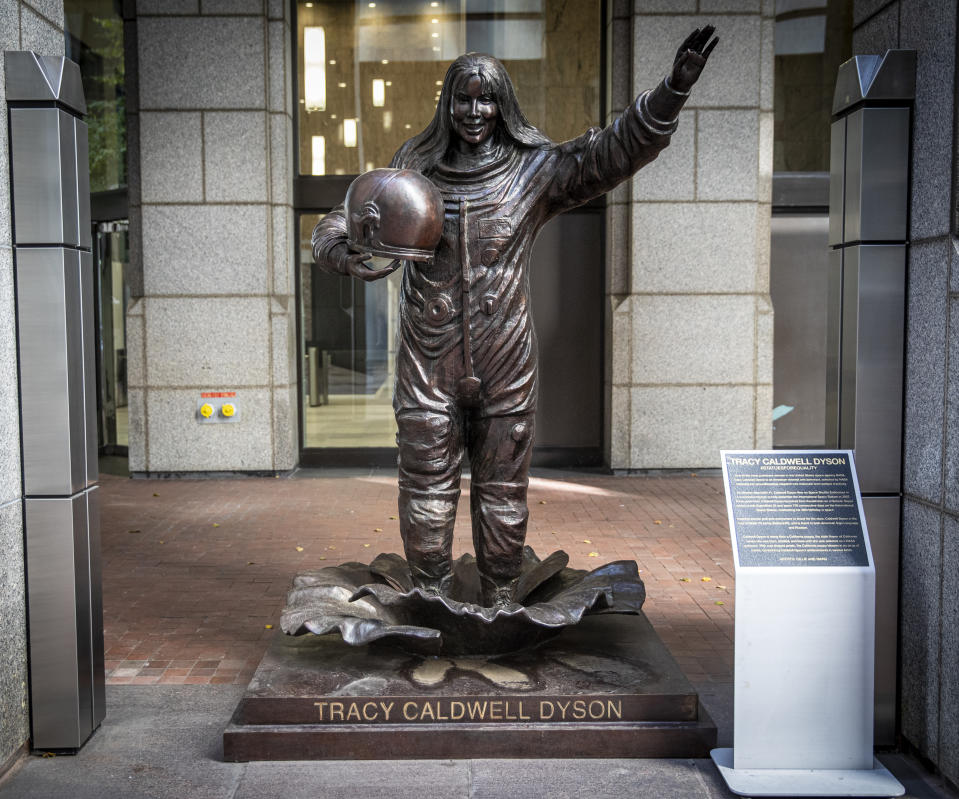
top-left (101, 471), bottom-right (733, 686)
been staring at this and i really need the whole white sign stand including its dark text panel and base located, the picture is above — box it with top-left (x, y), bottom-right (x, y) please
top-left (712, 450), bottom-right (905, 797)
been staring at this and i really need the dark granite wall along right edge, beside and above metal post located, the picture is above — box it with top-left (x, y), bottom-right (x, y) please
top-left (853, 0), bottom-right (959, 784)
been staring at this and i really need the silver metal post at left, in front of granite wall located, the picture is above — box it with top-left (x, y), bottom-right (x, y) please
top-left (4, 52), bottom-right (105, 752)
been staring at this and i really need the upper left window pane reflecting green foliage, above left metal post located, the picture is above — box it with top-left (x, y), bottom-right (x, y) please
top-left (63, 0), bottom-right (127, 192)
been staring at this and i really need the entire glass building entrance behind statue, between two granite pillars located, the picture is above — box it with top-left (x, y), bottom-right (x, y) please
top-left (294, 0), bottom-right (605, 465)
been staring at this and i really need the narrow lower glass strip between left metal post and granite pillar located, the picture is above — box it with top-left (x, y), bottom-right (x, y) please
top-left (96, 221), bottom-right (130, 454)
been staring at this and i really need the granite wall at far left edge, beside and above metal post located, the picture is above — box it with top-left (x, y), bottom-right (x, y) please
top-left (0, 0), bottom-right (64, 773)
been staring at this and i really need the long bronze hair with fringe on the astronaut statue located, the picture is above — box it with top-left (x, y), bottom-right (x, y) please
top-left (390, 53), bottom-right (553, 175)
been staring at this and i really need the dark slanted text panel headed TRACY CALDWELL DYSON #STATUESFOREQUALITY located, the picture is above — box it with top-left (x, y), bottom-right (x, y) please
top-left (723, 450), bottom-right (869, 567)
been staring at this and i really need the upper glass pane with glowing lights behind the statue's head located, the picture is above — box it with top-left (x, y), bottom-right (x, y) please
top-left (297, 0), bottom-right (601, 175)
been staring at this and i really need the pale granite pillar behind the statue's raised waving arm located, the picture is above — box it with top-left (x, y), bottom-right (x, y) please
top-left (605, 0), bottom-right (773, 471)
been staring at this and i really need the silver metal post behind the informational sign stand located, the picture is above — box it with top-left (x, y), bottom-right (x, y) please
top-left (826, 50), bottom-right (916, 745)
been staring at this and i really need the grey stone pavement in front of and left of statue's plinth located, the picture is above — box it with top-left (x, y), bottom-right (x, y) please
top-left (0, 685), bottom-right (950, 799)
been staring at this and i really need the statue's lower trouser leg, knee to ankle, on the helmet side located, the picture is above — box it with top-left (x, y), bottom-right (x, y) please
top-left (396, 410), bottom-right (463, 592)
